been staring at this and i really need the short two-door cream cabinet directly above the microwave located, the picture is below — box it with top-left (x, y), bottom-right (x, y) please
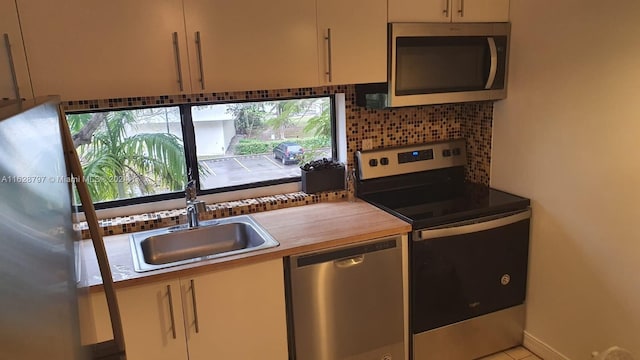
top-left (389, 0), bottom-right (509, 22)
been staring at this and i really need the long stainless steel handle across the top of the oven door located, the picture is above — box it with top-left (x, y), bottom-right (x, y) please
top-left (414, 209), bottom-right (531, 241)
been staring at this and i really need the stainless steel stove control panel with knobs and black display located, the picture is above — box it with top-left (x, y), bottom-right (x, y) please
top-left (356, 139), bottom-right (467, 180)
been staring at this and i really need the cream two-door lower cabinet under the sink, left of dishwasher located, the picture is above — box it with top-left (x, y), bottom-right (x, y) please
top-left (94, 259), bottom-right (288, 360)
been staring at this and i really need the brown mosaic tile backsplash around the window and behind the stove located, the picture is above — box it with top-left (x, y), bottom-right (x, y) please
top-left (62, 85), bottom-right (493, 238)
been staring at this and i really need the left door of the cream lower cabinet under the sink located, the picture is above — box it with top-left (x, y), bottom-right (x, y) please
top-left (117, 280), bottom-right (188, 360)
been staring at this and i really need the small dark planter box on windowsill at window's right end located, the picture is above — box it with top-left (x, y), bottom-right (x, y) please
top-left (300, 159), bottom-right (345, 194)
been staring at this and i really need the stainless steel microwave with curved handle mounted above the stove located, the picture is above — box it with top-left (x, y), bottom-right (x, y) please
top-left (356, 23), bottom-right (511, 108)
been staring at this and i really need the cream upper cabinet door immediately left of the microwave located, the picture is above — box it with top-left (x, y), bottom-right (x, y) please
top-left (317, 0), bottom-right (387, 84)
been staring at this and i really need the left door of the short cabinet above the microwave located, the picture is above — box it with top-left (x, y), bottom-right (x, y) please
top-left (389, 0), bottom-right (450, 22)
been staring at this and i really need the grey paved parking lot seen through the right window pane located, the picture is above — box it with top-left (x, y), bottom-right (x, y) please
top-left (200, 154), bottom-right (300, 189)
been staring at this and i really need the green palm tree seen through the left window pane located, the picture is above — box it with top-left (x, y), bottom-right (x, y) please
top-left (67, 110), bottom-right (186, 202)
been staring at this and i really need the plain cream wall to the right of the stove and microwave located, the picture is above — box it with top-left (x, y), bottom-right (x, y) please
top-left (491, 0), bottom-right (640, 360)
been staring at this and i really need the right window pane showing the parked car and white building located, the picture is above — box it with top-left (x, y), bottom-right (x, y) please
top-left (191, 97), bottom-right (332, 190)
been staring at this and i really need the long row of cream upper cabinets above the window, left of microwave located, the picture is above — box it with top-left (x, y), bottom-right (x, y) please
top-left (15, 0), bottom-right (392, 100)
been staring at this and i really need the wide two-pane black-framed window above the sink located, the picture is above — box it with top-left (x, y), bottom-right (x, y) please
top-left (67, 97), bottom-right (335, 208)
